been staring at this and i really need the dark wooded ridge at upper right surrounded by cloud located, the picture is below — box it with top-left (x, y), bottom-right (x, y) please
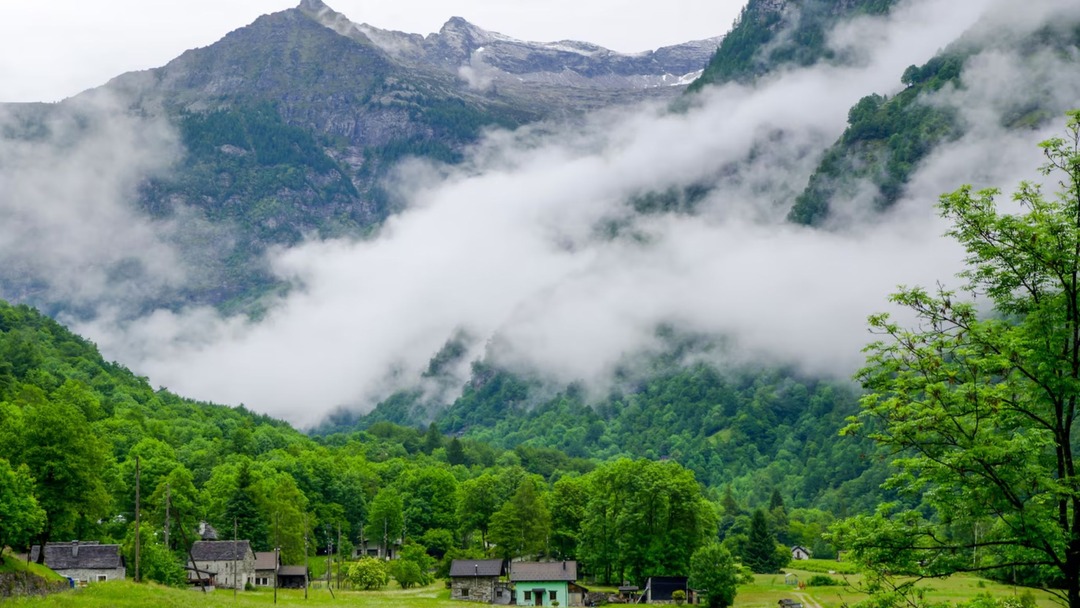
top-left (788, 14), bottom-right (1080, 225)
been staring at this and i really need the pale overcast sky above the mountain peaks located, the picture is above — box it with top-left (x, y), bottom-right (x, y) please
top-left (0, 0), bottom-right (745, 102)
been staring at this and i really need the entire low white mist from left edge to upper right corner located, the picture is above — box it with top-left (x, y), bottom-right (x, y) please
top-left (0, 0), bottom-right (1080, 427)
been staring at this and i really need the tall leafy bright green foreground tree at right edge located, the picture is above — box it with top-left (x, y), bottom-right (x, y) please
top-left (834, 111), bottom-right (1080, 608)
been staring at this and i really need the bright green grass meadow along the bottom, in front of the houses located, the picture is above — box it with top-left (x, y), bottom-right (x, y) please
top-left (3, 570), bottom-right (1058, 608)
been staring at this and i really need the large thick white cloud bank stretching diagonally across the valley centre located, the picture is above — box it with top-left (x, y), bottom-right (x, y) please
top-left (54, 0), bottom-right (1075, 424)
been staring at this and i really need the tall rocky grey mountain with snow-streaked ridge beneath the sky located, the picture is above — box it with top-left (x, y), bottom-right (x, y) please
top-left (0, 0), bottom-right (716, 310)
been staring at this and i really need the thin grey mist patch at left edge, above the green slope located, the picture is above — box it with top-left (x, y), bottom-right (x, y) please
top-left (0, 94), bottom-right (185, 317)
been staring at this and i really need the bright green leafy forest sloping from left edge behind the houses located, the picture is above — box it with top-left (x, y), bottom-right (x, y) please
top-left (0, 303), bottom-right (835, 584)
